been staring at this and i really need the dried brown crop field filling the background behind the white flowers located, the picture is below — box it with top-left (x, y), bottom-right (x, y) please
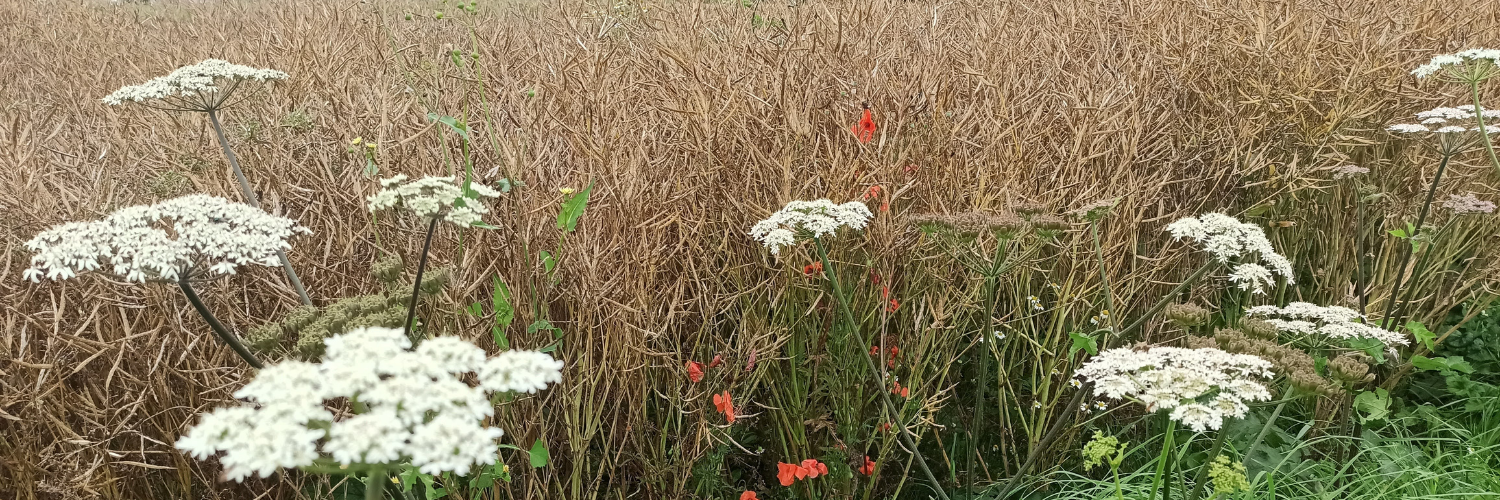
top-left (0, 0), bottom-right (1500, 500)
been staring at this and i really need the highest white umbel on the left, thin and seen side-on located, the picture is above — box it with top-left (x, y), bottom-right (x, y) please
top-left (102, 59), bottom-right (287, 111)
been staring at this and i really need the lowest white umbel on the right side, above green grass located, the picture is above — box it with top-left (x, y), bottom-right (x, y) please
top-left (1079, 347), bottom-right (1272, 432)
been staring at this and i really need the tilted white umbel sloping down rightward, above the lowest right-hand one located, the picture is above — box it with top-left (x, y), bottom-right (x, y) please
top-left (1167, 213), bottom-right (1295, 293)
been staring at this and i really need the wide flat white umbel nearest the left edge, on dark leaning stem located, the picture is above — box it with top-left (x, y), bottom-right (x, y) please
top-left (23, 194), bottom-right (312, 282)
